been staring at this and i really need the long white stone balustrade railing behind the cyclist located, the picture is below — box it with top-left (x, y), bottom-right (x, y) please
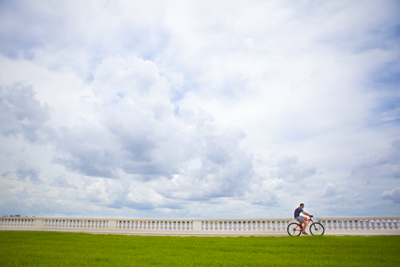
top-left (0, 217), bottom-right (400, 235)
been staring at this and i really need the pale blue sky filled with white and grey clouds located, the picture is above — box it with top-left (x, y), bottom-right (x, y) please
top-left (0, 0), bottom-right (400, 218)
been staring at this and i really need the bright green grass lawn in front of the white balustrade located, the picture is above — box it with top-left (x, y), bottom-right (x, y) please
top-left (0, 231), bottom-right (400, 266)
